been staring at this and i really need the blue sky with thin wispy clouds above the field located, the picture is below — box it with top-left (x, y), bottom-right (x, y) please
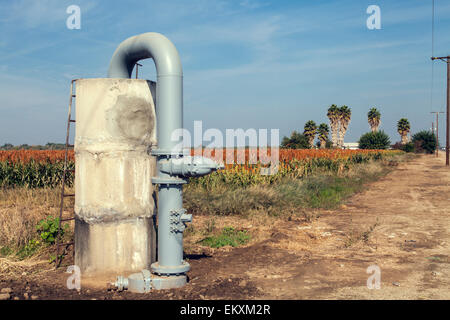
top-left (0, 0), bottom-right (450, 145)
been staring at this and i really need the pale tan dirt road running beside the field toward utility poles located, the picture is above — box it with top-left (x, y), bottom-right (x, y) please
top-left (243, 152), bottom-right (450, 299)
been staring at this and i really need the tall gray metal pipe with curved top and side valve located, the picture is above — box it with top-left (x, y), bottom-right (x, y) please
top-left (108, 32), bottom-right (221, 288)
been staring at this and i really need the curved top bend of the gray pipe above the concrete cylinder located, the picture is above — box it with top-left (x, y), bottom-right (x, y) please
top-left (108, 32), bottom-right (183, 78)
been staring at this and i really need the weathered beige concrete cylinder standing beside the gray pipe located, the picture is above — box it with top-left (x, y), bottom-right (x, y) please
top-left (75, 79), bottom-right (156, 274)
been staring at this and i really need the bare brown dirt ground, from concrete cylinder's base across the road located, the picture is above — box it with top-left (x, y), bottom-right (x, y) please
top-left (0, 152), bottom-right (450, 300)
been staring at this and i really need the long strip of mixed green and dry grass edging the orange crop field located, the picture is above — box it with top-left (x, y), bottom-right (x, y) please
top-left (184, 159), bottom-right (395, 216)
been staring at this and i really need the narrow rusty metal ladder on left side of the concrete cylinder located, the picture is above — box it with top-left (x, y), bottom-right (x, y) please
top-left (55, 79), bottom-right (77, 268)
